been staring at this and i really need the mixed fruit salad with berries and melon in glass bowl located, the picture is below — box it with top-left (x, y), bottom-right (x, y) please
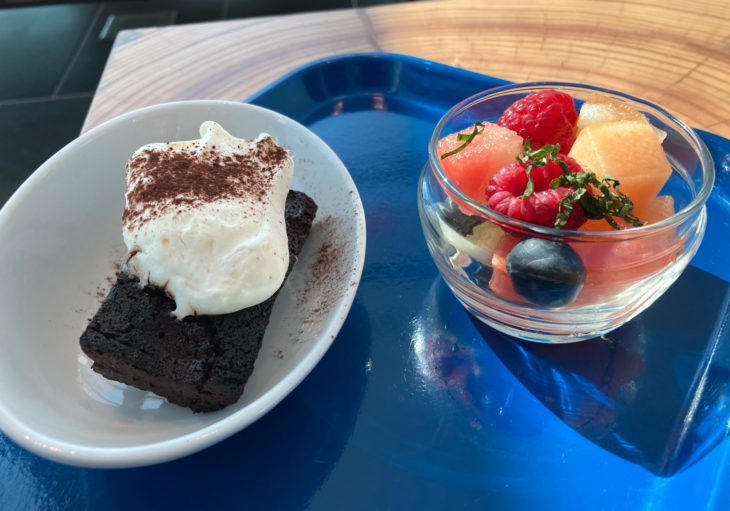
top-left (437, 90), bottom-right (684, 309)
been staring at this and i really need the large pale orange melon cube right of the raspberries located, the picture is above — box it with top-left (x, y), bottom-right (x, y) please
top-left (570, 121), bottom-right (672, 209)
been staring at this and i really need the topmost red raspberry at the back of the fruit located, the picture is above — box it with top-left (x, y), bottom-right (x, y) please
top-left (497, 90), bottom-right (578, 153)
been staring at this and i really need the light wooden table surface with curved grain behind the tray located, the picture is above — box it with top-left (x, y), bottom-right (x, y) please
top-left (84, 0), bottom-right (730, 137)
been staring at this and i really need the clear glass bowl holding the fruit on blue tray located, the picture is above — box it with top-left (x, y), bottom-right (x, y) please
top-left (418, 82), bottom-right (715, 343)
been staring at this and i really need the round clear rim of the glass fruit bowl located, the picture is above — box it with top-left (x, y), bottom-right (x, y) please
top-left (428, 82), bottom-right (715, 241)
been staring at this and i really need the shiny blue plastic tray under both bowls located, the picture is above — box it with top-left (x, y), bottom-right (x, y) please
top-left (0, 54), bottom-right (730, 511)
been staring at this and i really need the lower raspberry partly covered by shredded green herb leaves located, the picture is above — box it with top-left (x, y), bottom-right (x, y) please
top-left (484, 154), bottom-right (586, 231)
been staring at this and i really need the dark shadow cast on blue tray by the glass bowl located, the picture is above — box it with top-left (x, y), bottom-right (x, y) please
top-left (469, 267), bottom-right (730, 477)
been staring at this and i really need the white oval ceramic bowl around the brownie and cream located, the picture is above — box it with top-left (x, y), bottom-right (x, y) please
top-left (0, 101), bottom-right (365, 467)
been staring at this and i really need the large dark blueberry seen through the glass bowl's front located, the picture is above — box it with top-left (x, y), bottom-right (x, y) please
top-left (507, 238), bottom-right (586, 308)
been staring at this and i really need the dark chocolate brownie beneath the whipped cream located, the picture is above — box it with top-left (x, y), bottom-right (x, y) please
top-left (81, 191), bottom-right (317, 412)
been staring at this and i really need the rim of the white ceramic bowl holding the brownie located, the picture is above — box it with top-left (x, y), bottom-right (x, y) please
top-left (0, 100), bottom-right (366, 468)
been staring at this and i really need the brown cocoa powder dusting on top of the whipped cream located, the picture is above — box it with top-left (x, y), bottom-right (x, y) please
top-left (122, 137), bottom-right (287, 232)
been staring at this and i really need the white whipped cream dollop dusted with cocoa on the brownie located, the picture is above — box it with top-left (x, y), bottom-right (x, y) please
top-left (122, 121), bottom-right (294, 319)
